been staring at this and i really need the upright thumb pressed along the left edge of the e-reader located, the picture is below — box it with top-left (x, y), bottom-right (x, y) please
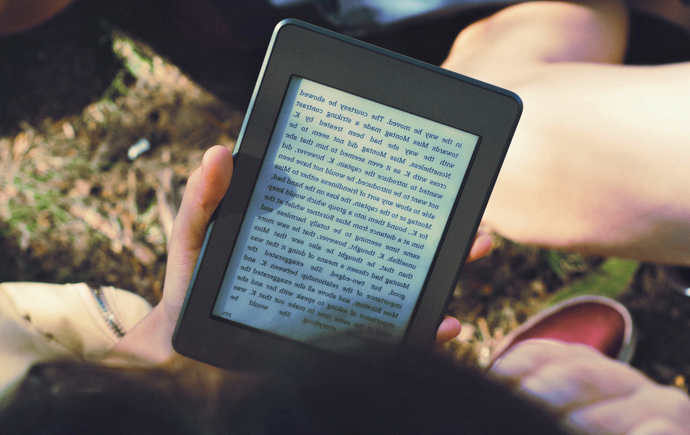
top-left (163, 146), bottom-right (232, 316)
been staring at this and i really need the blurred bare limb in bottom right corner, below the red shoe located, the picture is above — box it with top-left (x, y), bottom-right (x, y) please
top-left (491, 340), bottom-right (690, 435)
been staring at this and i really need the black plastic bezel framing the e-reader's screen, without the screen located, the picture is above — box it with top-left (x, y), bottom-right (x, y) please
top-left (173, 20), bottom-right (522, 370)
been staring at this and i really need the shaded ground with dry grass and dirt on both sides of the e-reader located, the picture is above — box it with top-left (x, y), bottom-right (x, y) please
top-left (0, 0), bottom-right (690, 391)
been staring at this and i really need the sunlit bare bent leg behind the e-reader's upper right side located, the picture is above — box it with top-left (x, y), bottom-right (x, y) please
top-left (444, 1), bottom-right (690, 264)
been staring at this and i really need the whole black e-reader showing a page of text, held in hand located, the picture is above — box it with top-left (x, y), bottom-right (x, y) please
top-left (173, 20), bottom-right (522, 370)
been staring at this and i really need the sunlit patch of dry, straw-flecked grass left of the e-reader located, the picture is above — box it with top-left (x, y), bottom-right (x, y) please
top-left (0, 30), bottom-right (242, 303)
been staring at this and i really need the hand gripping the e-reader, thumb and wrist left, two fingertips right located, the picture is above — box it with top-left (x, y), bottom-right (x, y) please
top-left (103, 146), bottom-right (491, 365)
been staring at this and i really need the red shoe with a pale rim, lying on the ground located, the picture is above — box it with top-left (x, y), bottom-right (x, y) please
top-left (490, 296), bottom-right (637, 366)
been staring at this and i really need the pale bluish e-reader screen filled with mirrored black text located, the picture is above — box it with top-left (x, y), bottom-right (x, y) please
top-left (212, 77), bottom-right (479, 347)
